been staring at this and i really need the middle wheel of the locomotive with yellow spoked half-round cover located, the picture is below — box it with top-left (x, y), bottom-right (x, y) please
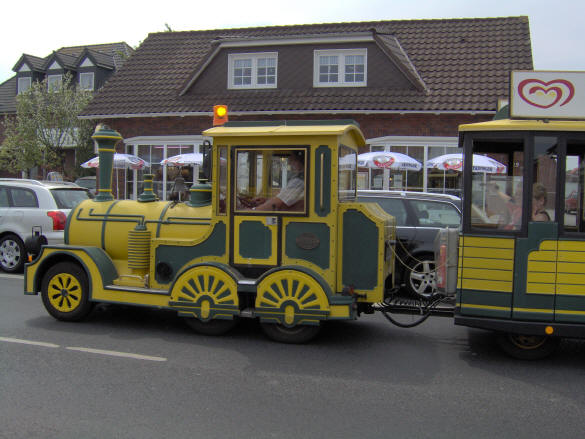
top-left (169, 265), bottom-right (239, 335)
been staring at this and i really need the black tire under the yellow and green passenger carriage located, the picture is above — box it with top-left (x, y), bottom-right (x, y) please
top-left (497, 333), bottom-right (560, 360)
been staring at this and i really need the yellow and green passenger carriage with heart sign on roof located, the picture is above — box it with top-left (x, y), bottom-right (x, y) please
top-left (448, 72), bottom-right (585, 359)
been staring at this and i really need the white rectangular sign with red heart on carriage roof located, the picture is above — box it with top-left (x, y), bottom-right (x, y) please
top-left (510, 71), bottom-right (585, 119)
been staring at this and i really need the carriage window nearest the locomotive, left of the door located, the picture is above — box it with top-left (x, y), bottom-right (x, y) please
top-left (468, 138), bottom-right (524, 231)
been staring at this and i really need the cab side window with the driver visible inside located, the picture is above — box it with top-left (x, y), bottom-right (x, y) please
top-left (234, 148), bottom-right (307, 213)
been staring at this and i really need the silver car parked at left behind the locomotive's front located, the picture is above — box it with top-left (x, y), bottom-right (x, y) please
top-left (0, 178), bottom-right (89, 273)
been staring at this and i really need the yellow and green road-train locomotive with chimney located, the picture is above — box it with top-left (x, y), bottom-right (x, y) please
top-left (25, 121), bottom-right (395, 343)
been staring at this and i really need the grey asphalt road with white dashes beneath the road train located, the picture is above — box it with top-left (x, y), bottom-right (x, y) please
top-left (0, 275), bottom-right (585, 439)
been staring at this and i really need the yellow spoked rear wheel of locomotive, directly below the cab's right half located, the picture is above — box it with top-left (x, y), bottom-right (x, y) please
top-left (256, 270), bottom-right (329, 343)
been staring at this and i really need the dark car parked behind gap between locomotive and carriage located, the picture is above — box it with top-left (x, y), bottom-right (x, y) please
top-left (358, 190), bottom-right (461, 298)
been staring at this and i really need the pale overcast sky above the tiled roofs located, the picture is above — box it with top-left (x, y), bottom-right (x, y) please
top-left (0, 0), bottom-right (585, 84)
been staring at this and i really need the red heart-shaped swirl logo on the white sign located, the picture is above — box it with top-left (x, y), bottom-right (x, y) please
top-left (518, 79), bottom-right (575, 108)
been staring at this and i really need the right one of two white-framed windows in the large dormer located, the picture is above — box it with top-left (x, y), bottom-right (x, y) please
top-left (313, 49), bottom-right (368, 87)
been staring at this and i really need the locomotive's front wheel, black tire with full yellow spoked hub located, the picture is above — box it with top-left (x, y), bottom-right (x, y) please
top-left (41, 262), bottom-right (94, 322)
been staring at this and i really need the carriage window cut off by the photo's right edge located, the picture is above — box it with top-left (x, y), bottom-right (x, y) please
top-left (563, 140), bottom-right (585, 233)
